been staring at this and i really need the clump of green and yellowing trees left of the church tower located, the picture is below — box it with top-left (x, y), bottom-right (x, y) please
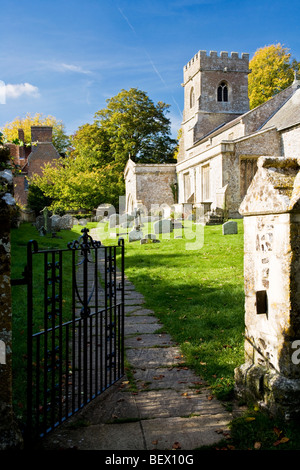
top-left (29, 88), bottom-right (177, 211)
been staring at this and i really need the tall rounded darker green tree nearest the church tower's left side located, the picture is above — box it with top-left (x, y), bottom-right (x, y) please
top-left (90, 88), bottom-right (177, 168)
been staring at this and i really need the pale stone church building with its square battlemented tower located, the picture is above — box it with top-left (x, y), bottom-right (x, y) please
top-left (125, 51), bottom-right (300, 223)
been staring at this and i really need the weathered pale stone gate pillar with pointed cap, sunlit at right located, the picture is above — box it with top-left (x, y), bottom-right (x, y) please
top-left (235, 157), bottom-right (300, 418)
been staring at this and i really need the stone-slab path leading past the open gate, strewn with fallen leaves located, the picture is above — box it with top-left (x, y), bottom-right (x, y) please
top-left (38, 233), bottom-right (232, 450)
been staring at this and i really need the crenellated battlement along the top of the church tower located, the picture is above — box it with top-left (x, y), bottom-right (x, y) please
top-left (183, 50), bottom-right (249, 82)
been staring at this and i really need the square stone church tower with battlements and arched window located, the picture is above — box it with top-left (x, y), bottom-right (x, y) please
top-left (179, 51), bottom-right (249, 160)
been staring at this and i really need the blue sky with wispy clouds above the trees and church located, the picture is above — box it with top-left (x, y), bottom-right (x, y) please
top-left (0, 0), bottom-right (300, 136)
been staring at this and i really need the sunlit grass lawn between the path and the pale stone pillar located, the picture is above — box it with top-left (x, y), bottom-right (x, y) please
top-left (104, 221), bottom-right (244, 399)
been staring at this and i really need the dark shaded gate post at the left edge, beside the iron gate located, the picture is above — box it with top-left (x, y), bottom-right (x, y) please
top-left (0, 170), bottom-right (23, 450)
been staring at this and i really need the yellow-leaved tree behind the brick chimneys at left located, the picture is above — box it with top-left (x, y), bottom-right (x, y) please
top-left (2, 113), bottom-right (70, 155)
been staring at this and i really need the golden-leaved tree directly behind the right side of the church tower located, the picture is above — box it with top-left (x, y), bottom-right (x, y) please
top-left (249, 44), bottom-right (298, 109)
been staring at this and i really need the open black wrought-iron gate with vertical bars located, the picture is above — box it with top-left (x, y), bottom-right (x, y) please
top-left (12, 228), bottom-right (124, 440)
